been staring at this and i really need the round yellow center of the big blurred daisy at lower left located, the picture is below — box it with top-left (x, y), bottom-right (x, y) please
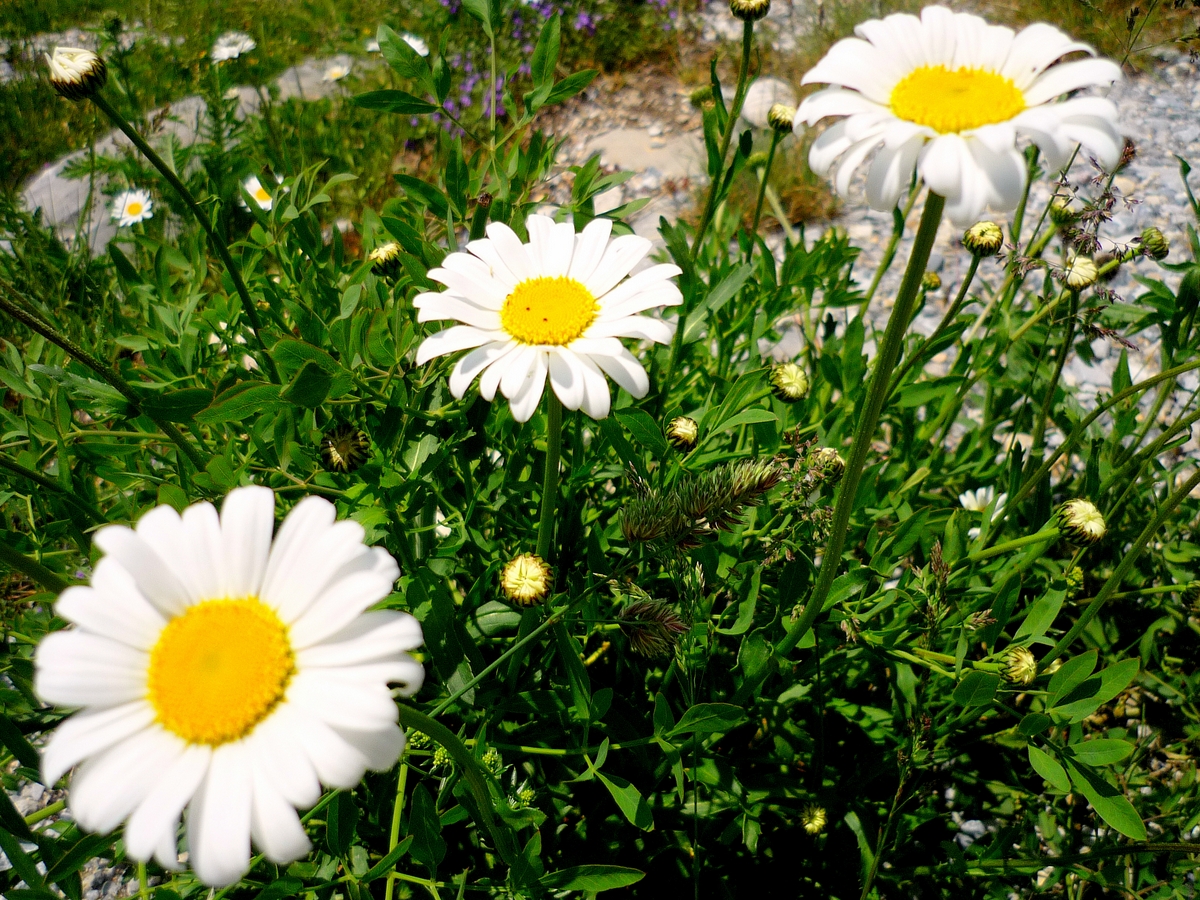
top-left (148, 598), bottom-right (295, 746)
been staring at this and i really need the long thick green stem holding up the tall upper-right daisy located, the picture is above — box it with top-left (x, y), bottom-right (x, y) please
top-left (775, 191), bottom-right (946, 658)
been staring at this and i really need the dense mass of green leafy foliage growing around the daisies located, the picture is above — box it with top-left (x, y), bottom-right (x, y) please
top-left (0, 0), bottom-right (1200, 900)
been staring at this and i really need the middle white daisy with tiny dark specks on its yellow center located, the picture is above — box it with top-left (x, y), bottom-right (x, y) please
top-left (413, 216), bottom-right (683, 422)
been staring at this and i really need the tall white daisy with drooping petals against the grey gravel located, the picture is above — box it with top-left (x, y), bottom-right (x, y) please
top-left (796, 6), bottom-right (1122, 224)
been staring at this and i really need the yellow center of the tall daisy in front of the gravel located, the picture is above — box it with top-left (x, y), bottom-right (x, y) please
top-left (892, 66), bottom-right (1025, 134)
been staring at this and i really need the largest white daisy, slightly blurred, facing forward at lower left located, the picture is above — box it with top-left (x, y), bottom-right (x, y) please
top-left (35, 487), bottom-right (424, 886)
